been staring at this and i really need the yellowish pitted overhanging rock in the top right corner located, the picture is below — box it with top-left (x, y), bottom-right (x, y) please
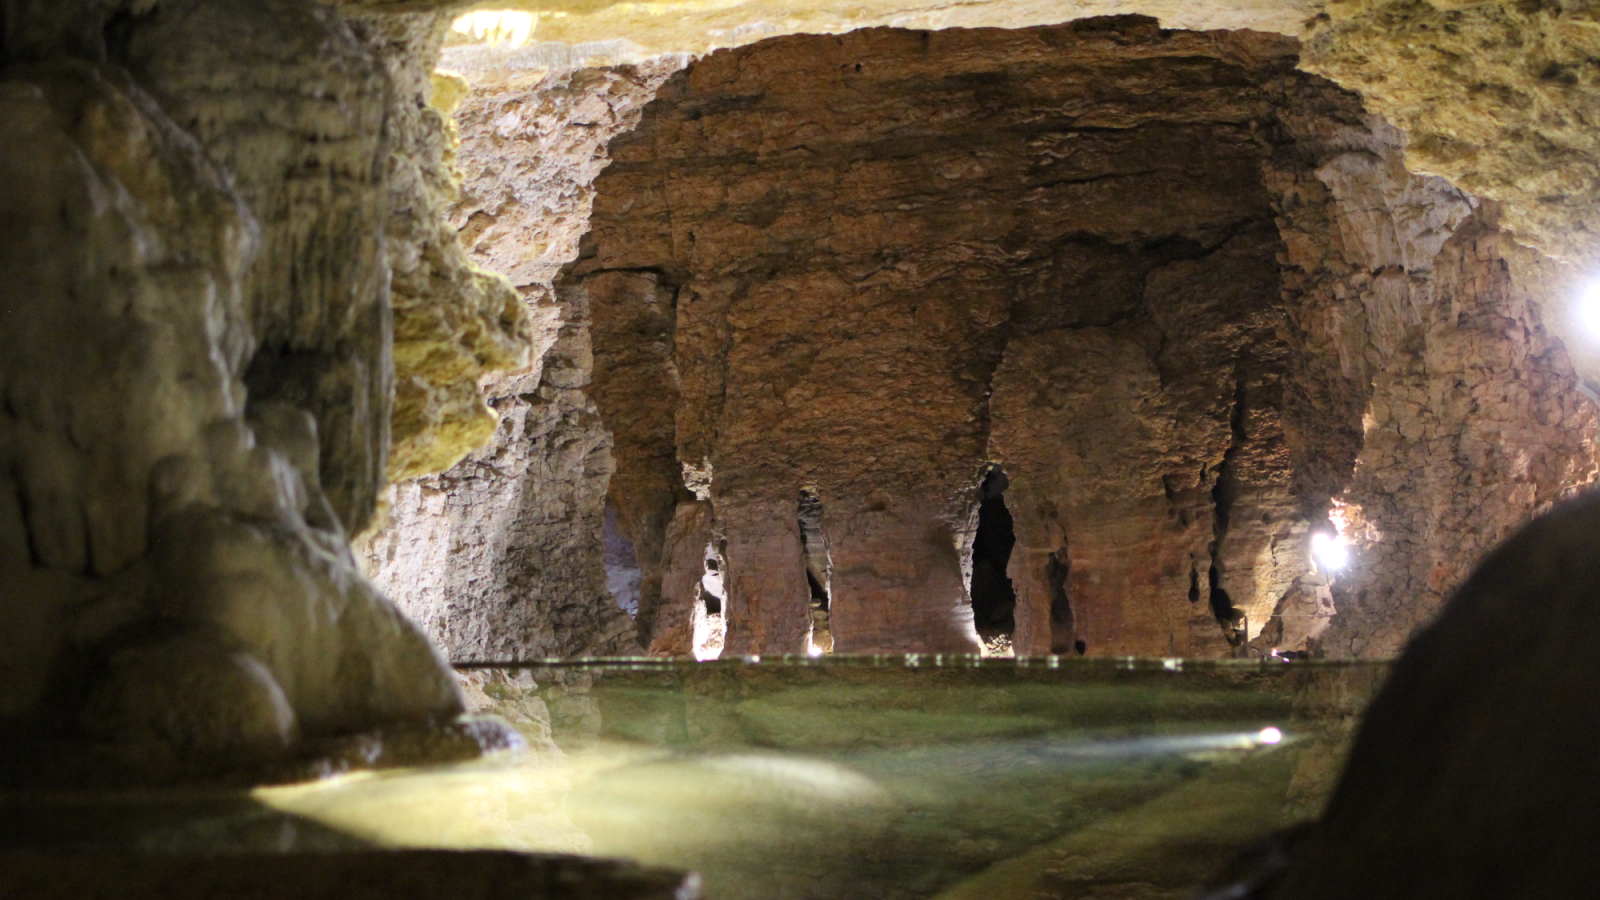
top-left (1304, 0), bottom-right (1600, 263)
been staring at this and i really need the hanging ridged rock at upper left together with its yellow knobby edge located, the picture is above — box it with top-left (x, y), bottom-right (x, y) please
top-left (126, 0), bottom-right (530, 518)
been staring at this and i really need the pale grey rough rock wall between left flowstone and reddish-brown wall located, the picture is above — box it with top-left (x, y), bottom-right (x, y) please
top-left (362, 58), bottom-right (698, 660)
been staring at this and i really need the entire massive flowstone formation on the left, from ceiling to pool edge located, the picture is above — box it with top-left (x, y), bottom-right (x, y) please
top-left (0, 0), bottom-right (526, 780)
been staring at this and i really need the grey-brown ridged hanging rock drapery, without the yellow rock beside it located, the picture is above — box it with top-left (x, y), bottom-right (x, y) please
top-left (122, 0), bottom-right (395, 530)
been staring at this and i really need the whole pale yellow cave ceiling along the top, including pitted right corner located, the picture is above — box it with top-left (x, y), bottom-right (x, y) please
top-left (334, 0), bottom-right (1600, 280)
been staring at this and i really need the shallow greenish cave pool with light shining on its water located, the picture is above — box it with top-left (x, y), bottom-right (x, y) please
top-left (0, 657), bottom-right (1384, 900)
